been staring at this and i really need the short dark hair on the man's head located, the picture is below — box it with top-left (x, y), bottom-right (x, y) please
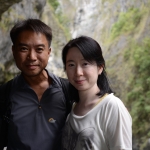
top-left (10, 19), bottom-right (52, 46)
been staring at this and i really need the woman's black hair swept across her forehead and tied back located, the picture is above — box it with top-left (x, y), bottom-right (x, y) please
top-left (62, 36), bottom-right (112, 100)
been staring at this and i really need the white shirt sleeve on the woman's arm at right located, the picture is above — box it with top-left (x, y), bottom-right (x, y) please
top-left (104, 96), bottom-right (132, 150)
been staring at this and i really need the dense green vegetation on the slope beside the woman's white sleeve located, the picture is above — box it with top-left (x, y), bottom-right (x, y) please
top-left (128, 38), bottom-right (150, 149)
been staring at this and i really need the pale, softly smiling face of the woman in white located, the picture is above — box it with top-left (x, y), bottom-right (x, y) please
top-left (66, 47), bottom-right (103, 92)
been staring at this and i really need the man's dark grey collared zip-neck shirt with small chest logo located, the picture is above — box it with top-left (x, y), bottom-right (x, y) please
top-left (8, 74), bottom-right (66, 150)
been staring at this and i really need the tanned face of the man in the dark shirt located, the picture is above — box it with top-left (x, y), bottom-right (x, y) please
top-left (12, 30), bottom-right (51, 77)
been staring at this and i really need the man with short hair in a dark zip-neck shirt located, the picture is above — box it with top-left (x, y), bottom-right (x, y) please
top-left (0, 19), bottom-right (73, 150)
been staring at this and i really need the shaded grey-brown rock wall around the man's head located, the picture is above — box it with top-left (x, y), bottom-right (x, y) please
top-left (0, 0), bottom-right (69, 83)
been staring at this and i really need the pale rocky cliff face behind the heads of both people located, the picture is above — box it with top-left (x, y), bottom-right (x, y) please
top-left (0, 0), bottom-right (150, 150)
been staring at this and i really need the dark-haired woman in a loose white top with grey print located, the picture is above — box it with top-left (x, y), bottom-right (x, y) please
top-left (62, 36), bottom-right (132, 150)
